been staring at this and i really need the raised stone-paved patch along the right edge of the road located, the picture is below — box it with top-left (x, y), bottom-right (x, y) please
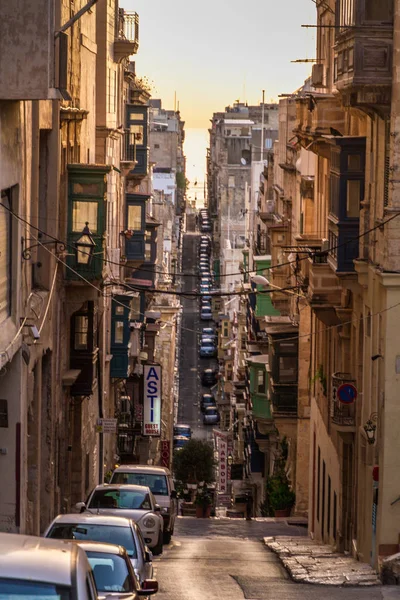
top-left (264, 536), bottom-right (381, 586)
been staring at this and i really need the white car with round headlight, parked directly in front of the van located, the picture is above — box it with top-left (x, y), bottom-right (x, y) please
top-left (76, 484), bottom-right (164, 554)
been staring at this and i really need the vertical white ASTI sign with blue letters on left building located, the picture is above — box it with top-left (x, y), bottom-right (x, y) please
top-left (143, 365), bottom-right (161, 436)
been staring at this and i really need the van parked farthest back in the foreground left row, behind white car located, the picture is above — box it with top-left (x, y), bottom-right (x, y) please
top-left (110, 465), bottom-right (178, 544)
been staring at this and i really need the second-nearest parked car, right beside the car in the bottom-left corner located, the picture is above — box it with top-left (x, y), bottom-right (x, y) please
top-left (75, 542), bottom-right (158, 600)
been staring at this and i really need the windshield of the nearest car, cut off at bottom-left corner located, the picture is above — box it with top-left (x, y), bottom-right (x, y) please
top-left (0, 577), bottom-right (71, 600)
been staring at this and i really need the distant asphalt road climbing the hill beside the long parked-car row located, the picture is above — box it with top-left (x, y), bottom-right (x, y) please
top-left (178, 232), bottom-right (216, 440)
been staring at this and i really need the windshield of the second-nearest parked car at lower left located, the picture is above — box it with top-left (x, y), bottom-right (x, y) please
top-left (86, 551), bottom-right (136, 592)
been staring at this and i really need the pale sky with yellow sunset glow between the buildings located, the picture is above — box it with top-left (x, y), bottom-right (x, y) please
top-left (120, 0), bottom-right (316, 202)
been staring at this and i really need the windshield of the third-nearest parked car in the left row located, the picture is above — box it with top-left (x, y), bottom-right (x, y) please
top-left (47, 523), bottom-right (137, 558)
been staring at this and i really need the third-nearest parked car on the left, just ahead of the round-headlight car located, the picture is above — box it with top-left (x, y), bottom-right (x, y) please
top-left (44, 513), bottom-right (153, 585)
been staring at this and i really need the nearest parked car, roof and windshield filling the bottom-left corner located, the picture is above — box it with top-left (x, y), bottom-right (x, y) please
top-left (0, 533), bottom-right (97, 600)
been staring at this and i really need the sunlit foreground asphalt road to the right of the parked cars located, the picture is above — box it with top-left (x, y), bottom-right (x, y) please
top-left (155, 517), bottom-right (400, 600)
